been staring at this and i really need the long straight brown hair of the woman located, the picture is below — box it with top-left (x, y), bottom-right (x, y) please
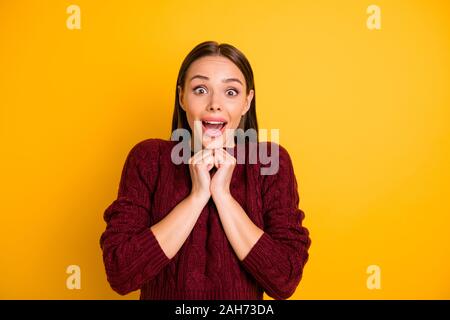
top-left (172, 41), bottom-right (258, 140)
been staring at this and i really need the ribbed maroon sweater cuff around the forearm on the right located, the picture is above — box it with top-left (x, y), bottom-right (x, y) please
top-left (242, 232), bottom-right (274, 274)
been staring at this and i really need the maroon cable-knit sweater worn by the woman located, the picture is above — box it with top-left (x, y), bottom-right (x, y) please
top-left (100, 139), bottom-right (311, 300)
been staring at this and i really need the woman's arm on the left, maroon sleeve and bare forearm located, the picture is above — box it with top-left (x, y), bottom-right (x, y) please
top-left (100, 141), bottom-right (207, 295)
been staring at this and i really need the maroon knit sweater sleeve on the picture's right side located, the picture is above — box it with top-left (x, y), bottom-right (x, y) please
top-left (242, 146), bottom-right (311, 300)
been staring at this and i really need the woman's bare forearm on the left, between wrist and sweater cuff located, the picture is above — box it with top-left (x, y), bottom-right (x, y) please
top-left (150, 194), bottom-right (208, 259)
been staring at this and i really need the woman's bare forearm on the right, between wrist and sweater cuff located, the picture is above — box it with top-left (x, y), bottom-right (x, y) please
top-left (214, 194), bottom-right (264, 261)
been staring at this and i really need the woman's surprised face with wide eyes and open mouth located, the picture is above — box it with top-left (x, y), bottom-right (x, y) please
top-left (178, 56), bottom-right (254, 148)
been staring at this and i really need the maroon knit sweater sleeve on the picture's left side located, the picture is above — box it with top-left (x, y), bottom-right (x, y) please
top-left (100, 139), bottom-right (170, 295)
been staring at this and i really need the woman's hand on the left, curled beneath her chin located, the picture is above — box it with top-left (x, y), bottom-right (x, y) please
top-left (189, 149), bottom-right (214, 203)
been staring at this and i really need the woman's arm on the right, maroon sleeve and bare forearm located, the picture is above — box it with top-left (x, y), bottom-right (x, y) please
top-left (213, 147), bottom-right (310, 299)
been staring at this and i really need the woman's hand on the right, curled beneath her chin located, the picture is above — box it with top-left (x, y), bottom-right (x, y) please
top-left (210, 148), bottom-right (236, 199)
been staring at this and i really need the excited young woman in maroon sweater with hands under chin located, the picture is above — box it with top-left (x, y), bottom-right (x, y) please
top-left (100, 41), bottom-right (311, 300)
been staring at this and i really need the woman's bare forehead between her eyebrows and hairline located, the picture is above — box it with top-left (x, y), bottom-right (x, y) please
top-left (187, 56), bottom-right (245, 81)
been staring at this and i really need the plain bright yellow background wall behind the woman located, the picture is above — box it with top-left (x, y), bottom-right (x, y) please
top-left (0, 0), bottom-right (450, 299)
